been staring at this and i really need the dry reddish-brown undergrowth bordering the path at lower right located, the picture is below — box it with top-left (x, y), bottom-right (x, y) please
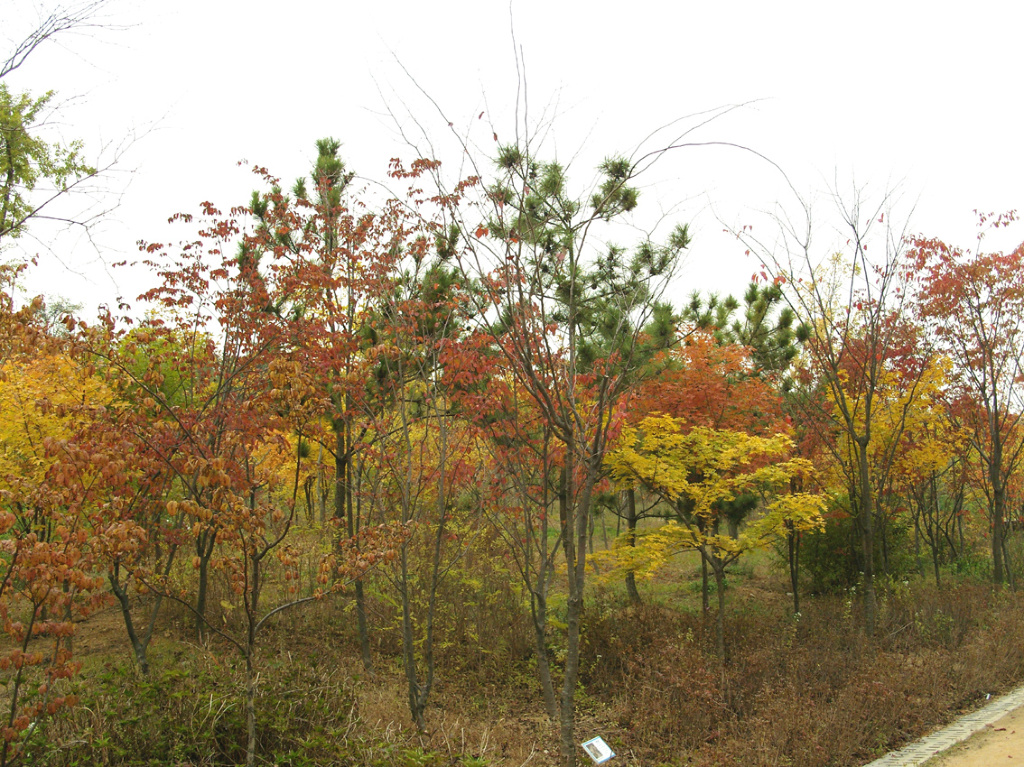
top-left (584, 581), bottom-right (1024, 767)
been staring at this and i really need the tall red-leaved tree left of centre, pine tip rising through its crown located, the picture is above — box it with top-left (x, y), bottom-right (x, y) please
top-left (238, 138), bottom-right (406, 673)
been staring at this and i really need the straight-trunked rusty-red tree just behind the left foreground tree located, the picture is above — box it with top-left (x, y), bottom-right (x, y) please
top-left (125, 204), bottom-right (280, 639)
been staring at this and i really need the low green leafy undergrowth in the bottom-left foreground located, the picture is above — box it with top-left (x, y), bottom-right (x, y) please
top-left (30, 650), bottom-right (358, 767)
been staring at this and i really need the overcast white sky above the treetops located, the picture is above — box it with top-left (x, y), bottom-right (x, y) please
top-left (0, 0), bottom-right (1024, 311)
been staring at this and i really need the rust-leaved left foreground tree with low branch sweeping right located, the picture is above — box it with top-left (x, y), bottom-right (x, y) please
top-left (61, 195), bottom-right (401, 764)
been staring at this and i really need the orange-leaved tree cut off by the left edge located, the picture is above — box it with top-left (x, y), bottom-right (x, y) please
top-left (0, 303), bottom-right (109, 765)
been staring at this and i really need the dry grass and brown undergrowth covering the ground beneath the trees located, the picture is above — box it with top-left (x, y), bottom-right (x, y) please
top-left (25, 536), bottom-right (1024, 767)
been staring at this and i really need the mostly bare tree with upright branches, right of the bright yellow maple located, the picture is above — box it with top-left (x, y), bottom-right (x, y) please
top-left (737, 193), bottom-right (928, 634)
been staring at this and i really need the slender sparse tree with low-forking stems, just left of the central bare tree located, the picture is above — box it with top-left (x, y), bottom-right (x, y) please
top-left (360, 201), bottom-right (482, 731)
